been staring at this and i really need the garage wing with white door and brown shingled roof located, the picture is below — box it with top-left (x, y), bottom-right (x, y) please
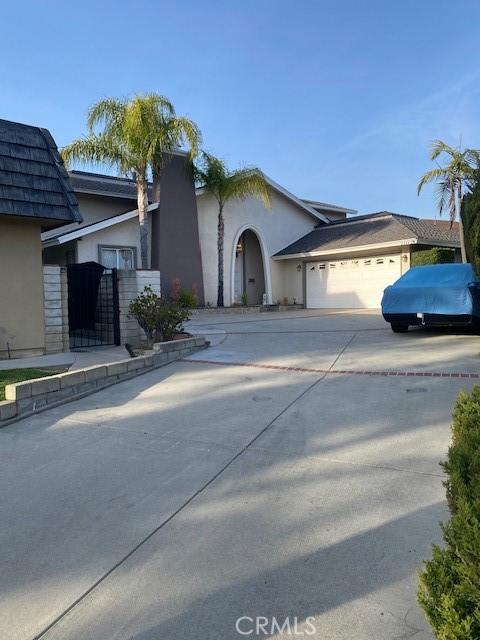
top-left (273, 211), bottom-right (460, 309)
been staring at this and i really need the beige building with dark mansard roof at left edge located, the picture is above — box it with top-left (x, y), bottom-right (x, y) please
top-left (0, 120), bottom-right (82, 357)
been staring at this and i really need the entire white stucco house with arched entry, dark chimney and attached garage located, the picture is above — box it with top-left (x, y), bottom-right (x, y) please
top-left (43, 164), bottom-right (459, 308)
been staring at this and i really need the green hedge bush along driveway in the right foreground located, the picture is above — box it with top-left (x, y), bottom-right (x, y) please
top-left (418, 386), bottom-right (480, 640)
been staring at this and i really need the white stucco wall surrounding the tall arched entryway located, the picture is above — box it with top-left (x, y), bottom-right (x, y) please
top-left (197, 192), bottom-right (315, 305)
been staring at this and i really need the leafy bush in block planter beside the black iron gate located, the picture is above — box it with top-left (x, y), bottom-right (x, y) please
top-left (128, 285), bottom-right (190, 345)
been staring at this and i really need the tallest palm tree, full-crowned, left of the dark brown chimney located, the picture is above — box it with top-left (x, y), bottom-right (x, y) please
top-left (62, 93), bottom-right (201, 269)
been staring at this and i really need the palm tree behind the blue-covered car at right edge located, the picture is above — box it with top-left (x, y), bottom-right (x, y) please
top-left (417, 140), bottom-right (480, 262)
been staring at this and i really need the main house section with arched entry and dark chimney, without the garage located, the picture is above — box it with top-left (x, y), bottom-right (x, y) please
top-left (42, 170), bottom-right (353, 306)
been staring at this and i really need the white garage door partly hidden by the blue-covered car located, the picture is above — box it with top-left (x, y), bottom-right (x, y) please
top-left (305, 254), bottom-right (401, 309)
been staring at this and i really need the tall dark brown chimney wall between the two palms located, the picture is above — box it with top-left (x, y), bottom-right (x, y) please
top-left (152, 155), bottom-right (203, 304)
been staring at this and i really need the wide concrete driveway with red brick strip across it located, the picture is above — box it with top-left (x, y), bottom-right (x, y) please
top-left (0, 311), bottom-right (480, 640)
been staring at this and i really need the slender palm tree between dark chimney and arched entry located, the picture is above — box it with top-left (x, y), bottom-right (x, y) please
top-left (195, 152), bottom-right (271, 307)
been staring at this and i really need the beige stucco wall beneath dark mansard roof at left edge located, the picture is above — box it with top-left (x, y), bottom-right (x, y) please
top-left (0, 216), bottom-right (45, 357)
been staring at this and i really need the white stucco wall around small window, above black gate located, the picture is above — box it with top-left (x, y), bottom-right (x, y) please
top-left (77, 218), bottom-right (140, 266)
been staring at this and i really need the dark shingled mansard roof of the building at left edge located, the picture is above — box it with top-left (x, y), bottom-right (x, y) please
top-left (0, 119), bottom-right (82, 226)
